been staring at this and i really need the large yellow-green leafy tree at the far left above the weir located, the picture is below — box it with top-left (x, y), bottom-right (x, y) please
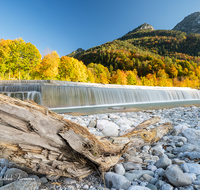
top-left (0, 38), bottom-right (41, 79)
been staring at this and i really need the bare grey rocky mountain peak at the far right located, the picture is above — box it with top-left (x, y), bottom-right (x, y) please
top-left (173, 12), bottom-right (200, 34)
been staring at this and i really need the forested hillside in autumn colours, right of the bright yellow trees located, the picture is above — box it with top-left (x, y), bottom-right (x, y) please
top-left (69, 23), bottom-right (200, 88)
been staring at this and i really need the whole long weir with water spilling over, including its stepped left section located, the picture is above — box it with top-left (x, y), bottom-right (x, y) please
top-left (0, 80), bottom-right (200, 108)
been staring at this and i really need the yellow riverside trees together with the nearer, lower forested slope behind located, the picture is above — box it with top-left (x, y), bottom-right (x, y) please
top-left (0, 38), bottom-right (200, 88)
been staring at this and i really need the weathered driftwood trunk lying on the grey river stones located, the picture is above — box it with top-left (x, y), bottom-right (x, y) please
top-left (0, 95), bottom-right (172, 179)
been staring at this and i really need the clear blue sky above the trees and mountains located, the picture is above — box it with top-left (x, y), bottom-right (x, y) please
top-left (0, 0), bottom-right (200, 57)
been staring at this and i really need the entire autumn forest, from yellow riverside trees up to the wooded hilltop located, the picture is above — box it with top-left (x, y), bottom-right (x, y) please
top-left (0, 29), bottom-right (200, 88)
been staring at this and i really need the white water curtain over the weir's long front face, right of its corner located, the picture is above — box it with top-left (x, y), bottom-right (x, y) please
top-left (41, 85), bottom-right (200, 108)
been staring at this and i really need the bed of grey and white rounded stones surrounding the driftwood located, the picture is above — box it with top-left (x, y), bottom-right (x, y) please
top-left (0, 106), bottom-right (200, 190)
